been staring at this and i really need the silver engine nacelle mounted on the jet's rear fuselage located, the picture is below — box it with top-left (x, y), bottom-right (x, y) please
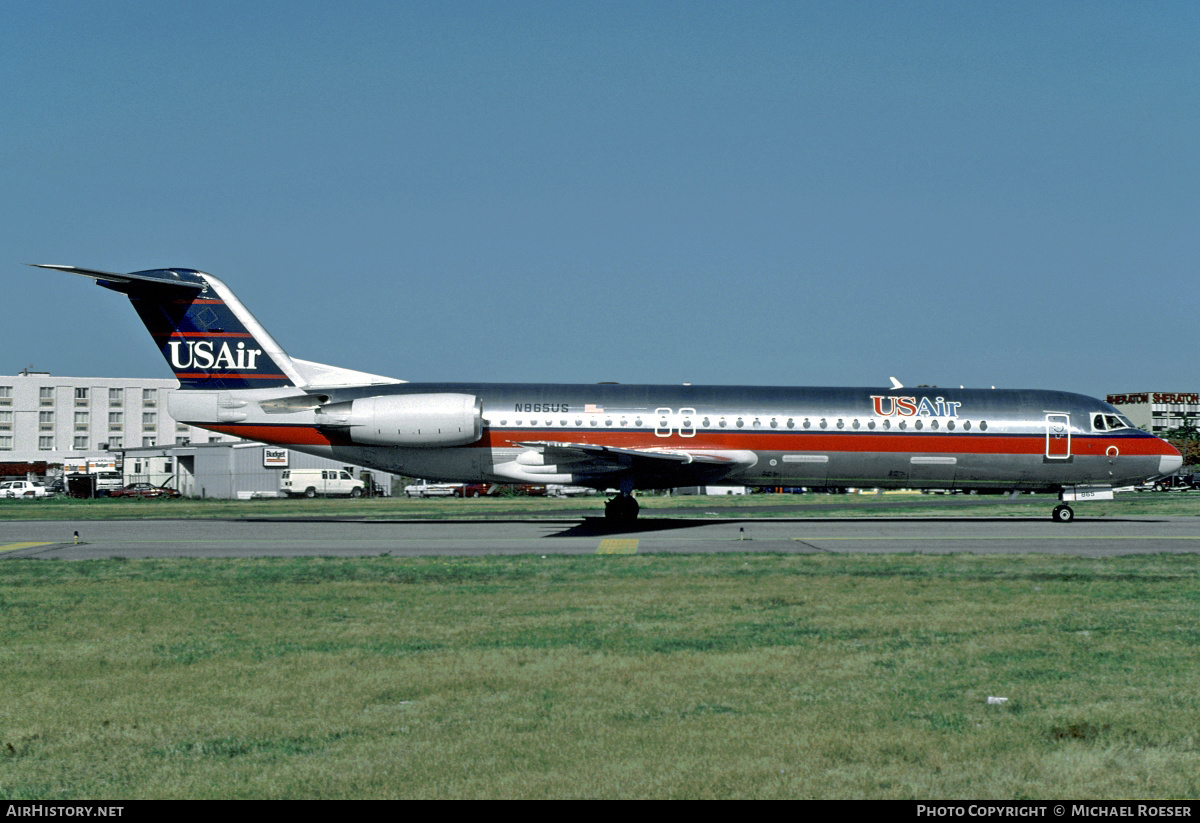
top-left (346, 394), bottom-right (484, 447)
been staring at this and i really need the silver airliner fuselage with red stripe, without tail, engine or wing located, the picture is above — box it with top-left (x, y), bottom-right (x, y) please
top-left (187, 383), bottom-right (1180, 491)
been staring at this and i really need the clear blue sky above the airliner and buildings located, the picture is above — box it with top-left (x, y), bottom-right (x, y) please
top-left (0, 0), bottom-right (1200, 395)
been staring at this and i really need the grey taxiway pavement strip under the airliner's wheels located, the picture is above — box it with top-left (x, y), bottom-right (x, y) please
top-left (0, 517), bottom-right (1200, 559)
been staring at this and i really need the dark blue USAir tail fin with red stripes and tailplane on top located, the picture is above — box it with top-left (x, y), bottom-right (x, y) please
top-left (37, 264), bottom-right (307, 391)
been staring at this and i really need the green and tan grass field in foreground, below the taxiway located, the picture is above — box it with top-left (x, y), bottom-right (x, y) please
top-left (0, 544), bottom-right (1200, 799)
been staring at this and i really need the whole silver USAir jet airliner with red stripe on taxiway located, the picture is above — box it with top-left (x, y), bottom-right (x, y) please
top-left (41, 265), bottom-right (1183, 522)
